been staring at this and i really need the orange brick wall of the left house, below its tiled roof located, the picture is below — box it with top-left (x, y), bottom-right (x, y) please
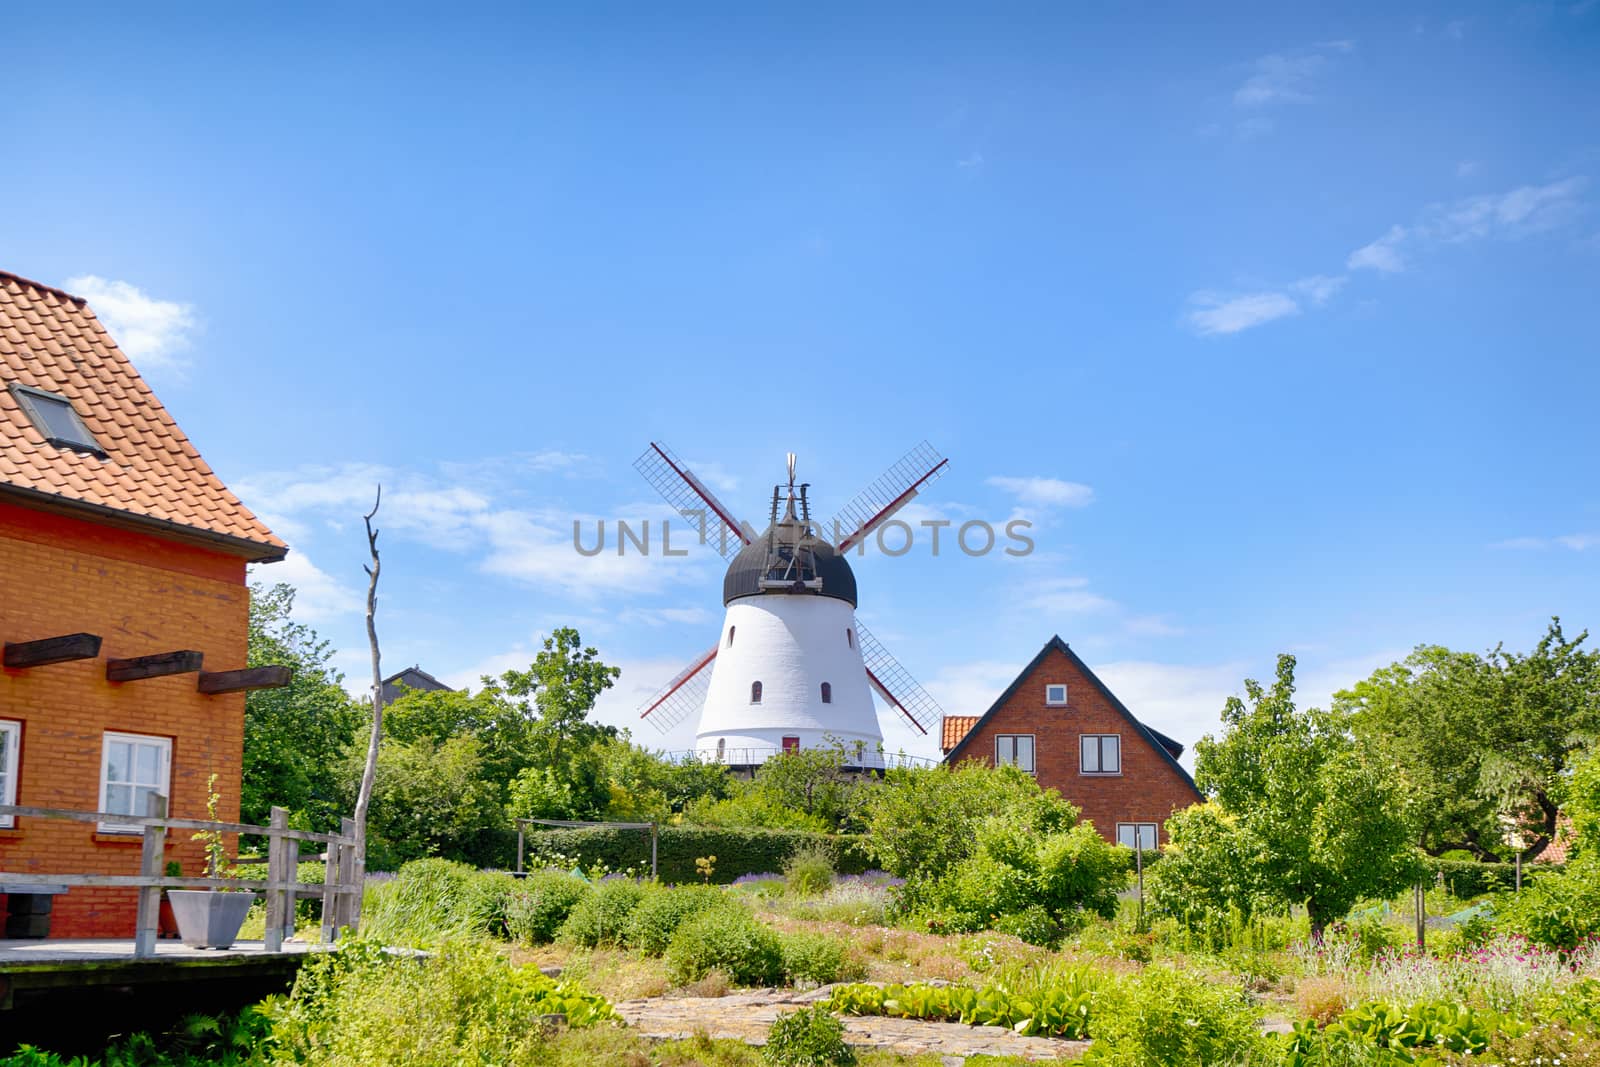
top-left (0, 504), bottom-right (250, 937)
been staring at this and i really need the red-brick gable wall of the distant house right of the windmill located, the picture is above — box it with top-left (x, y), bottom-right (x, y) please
top-left (957, 648), bottom-right (1200, 841)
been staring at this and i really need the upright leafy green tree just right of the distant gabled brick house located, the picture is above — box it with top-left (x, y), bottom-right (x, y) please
top-left (1195, 656), bottom-right (1421, 933)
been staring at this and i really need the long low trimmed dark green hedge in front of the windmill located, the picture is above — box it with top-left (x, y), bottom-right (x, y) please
top-left (528, 825), bottom-right (875, 885)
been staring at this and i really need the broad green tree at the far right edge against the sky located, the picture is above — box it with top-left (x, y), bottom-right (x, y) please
top-left (1336, 619), bottom-right (1600, 859)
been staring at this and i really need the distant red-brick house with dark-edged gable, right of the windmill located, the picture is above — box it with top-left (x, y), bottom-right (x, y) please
top-left (941, 637), bottom-right (1202, 848)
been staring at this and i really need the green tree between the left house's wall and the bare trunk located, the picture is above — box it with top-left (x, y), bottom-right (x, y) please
top-left (238, 582), bottom-right (365, 830)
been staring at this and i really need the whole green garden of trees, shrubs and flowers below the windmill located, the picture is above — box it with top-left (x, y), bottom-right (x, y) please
top-left (6, 591), bottom-right (1600, 1067)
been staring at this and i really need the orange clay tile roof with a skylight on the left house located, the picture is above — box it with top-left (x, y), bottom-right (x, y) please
top-left (0, 272), bottom-right (288, 560)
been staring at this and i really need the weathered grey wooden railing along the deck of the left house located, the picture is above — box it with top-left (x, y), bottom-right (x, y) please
top-left (0, 795), bottom-right (362, 958)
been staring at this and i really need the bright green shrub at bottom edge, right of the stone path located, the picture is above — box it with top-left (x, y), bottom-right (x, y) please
top-left (1086, 966), bottom-right (1264, 1067)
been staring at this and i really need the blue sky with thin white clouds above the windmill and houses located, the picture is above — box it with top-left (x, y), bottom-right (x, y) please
top-left (0, 0), bottom-right (1600, 755)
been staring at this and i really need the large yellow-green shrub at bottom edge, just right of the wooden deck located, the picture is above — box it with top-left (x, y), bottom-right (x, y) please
top-left (262, 939), bottom-right (616, 1067)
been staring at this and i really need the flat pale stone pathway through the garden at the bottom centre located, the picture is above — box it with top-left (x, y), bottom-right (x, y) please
top-left (616, 985), bottom-right (1088, 1067)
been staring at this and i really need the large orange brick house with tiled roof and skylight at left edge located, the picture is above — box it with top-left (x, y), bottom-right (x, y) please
top-left (0, 272), bottom-right (286, 937)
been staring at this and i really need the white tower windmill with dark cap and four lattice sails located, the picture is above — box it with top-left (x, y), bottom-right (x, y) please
top-left (634, 442), bottom-right (949, 766)
